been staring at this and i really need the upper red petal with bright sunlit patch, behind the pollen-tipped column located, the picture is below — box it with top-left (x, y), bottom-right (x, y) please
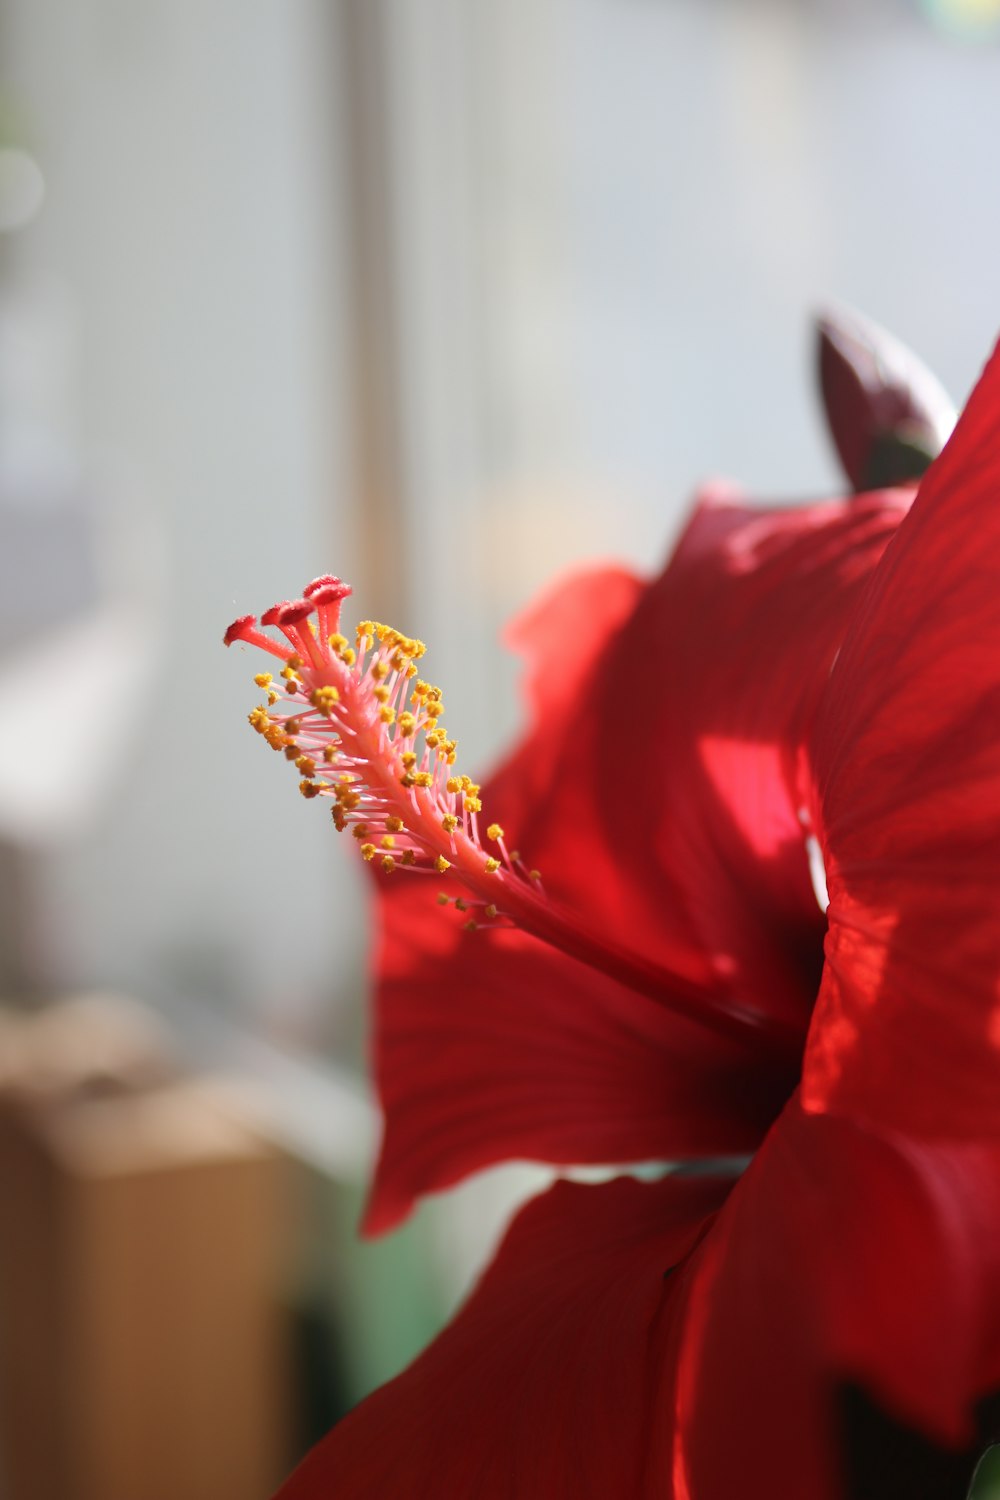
top-left (485, 492), bottom-right (909, 1028)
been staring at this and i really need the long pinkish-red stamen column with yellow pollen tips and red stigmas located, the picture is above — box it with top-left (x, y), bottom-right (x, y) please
top-left (223, 573), bottom-right (801, 1061)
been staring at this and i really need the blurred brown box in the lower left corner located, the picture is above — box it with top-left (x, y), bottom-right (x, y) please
top-left (0, 996), bottom-right (289, 1500)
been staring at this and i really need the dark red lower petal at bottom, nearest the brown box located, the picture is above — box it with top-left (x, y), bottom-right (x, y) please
top-left (280, 1178), bottom-right (726, 1500)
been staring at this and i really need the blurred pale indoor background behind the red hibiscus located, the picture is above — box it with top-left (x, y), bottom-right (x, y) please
top-left (0, 0), bottom-right (1000, 1500)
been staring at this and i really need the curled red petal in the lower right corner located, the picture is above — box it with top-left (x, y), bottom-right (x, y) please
top-left (676, 1106), bottom-right (1000, 1500)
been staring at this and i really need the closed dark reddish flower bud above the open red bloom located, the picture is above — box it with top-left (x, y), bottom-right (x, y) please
top-left (816, 309), bottom-right (955, 491)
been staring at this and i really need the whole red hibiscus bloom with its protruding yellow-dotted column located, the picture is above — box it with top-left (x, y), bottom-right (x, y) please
top-left (226, 334), bottom-right (1000, 1500)
